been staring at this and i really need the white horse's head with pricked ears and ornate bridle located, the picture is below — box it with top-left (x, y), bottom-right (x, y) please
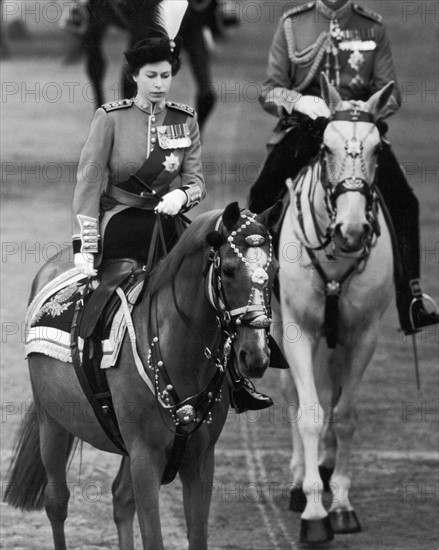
top-left (321, 75), bottom-right (394, 252)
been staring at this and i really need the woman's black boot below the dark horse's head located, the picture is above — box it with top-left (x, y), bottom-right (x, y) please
top-left (226, 361), bottom-right (273, 414)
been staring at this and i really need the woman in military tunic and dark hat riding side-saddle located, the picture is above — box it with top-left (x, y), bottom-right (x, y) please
top-left (73, 34), bottom-right (205, 275)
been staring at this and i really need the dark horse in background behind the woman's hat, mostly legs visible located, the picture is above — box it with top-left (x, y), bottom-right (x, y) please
top-left (72, 0), bottom-right (218, 128)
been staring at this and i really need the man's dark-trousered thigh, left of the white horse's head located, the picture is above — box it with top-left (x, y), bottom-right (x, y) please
top-left (248, 119), bottom-right (323, 214)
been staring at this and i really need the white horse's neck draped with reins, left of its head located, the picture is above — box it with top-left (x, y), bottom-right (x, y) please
top-left (290, 162), bottom-right (331, 248)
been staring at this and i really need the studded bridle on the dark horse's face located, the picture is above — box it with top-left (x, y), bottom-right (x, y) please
top-left (205, 214), bottom-right (273, 330)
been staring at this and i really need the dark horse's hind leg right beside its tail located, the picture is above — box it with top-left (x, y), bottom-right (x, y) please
top-left (40, 415), bottom-right (72, 550)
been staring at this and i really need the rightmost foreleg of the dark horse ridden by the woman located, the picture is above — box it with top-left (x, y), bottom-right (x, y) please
top-left (180, 449), bottom-right (214, 550)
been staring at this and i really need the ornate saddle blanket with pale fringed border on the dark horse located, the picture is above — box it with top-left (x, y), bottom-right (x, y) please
top-left (25, 268), bottom-right (143, 369)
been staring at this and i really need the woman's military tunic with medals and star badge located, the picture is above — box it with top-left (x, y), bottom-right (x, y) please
top-left (73, 96), bottom-right (205, 264)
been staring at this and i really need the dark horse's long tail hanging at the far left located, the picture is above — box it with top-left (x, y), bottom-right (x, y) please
top-left (3, 402), bottom-right (74, 510)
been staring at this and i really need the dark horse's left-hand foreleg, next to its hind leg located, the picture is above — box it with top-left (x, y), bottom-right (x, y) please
top-left (129, 446), bottom-right (165, 550)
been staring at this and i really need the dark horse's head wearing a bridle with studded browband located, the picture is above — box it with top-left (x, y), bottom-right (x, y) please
top-left (207, 203), bottom-right (281, 378)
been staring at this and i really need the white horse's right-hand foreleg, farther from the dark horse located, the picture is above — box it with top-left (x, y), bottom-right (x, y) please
top-left (329, 331), bottom-right (376, 533)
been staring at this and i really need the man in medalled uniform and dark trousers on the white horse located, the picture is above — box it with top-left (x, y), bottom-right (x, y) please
top-left (249, 0), bottom-right (439, 334)
